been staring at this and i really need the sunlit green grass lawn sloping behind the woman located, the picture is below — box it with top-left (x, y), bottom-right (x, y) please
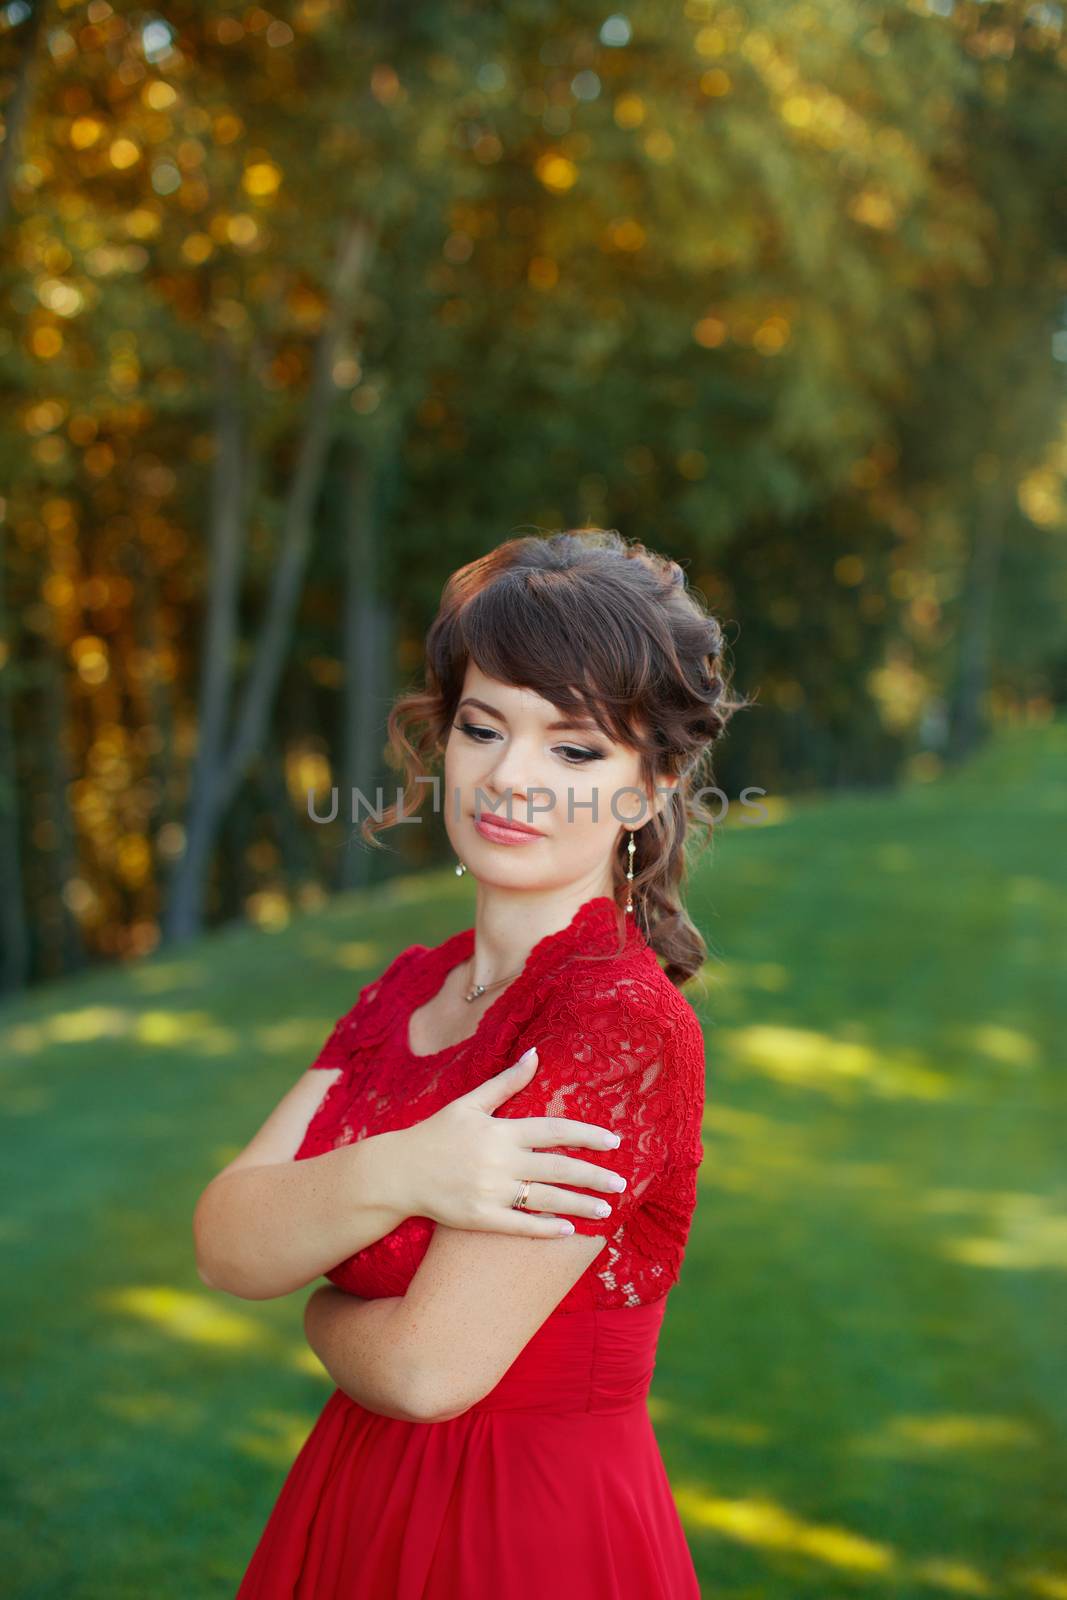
top-left (0, 725), bottom-right (1067, 1600)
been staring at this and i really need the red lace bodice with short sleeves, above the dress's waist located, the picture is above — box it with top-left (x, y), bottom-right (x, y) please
top-left (296, 894), bottom-right (704, 1310)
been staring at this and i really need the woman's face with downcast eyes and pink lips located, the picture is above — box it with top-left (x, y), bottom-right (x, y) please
top-left (443, 661), bottom-right (673, 894)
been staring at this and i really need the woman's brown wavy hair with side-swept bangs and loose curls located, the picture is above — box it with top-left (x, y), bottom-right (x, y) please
top-left (362, 528), bottom-right (749, 987)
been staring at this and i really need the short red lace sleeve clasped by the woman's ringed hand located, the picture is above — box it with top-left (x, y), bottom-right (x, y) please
top-left (496, 979), bottom-right (702, 1238)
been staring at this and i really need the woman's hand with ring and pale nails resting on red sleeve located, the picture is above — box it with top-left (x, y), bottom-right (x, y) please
top-left (387, 1048), bottom-right (625, 1238)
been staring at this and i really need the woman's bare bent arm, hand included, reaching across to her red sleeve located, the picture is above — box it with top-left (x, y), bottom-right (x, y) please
top-left (194, 1054), bottom-right (630, 1299)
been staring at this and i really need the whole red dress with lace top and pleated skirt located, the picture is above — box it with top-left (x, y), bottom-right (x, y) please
top-left (237, 896), bottom-right (704, 1600)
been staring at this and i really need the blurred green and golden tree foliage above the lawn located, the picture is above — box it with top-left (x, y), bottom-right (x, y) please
top-left (0, 0), bottom-right (1067, 970)
